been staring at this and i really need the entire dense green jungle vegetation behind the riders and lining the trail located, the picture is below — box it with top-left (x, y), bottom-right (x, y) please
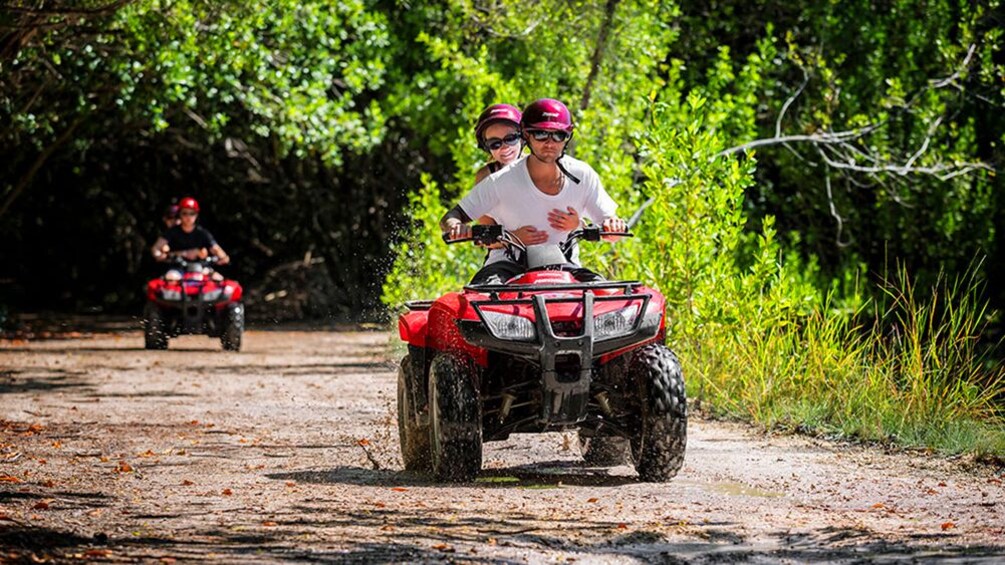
top-left (0, 0), bottom-right (1005, 456)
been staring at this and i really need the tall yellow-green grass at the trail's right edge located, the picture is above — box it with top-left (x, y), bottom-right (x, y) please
top-left (680, 269), bottom-right (1005, 457)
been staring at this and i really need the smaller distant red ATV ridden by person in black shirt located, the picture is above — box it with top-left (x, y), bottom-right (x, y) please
top-left (144, 256), bottom-right (244, 351)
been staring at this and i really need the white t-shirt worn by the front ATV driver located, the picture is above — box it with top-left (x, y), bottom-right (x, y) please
top-left (459, 155), bottom-right (617, 264)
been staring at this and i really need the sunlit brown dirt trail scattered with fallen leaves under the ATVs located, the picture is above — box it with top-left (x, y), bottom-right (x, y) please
top-left (0, 332), bottom-right (1005, 563)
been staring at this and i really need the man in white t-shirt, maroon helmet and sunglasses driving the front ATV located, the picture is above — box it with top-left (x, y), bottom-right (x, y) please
top-left (440, 99), bottom-right (625, 285)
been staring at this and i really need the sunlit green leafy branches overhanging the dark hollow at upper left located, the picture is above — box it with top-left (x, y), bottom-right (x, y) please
top-left (4, 0), bottom-right (389, 164)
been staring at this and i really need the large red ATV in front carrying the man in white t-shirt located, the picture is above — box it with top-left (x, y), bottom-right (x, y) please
top-left (398, 226), bottom-right (687, 482)
